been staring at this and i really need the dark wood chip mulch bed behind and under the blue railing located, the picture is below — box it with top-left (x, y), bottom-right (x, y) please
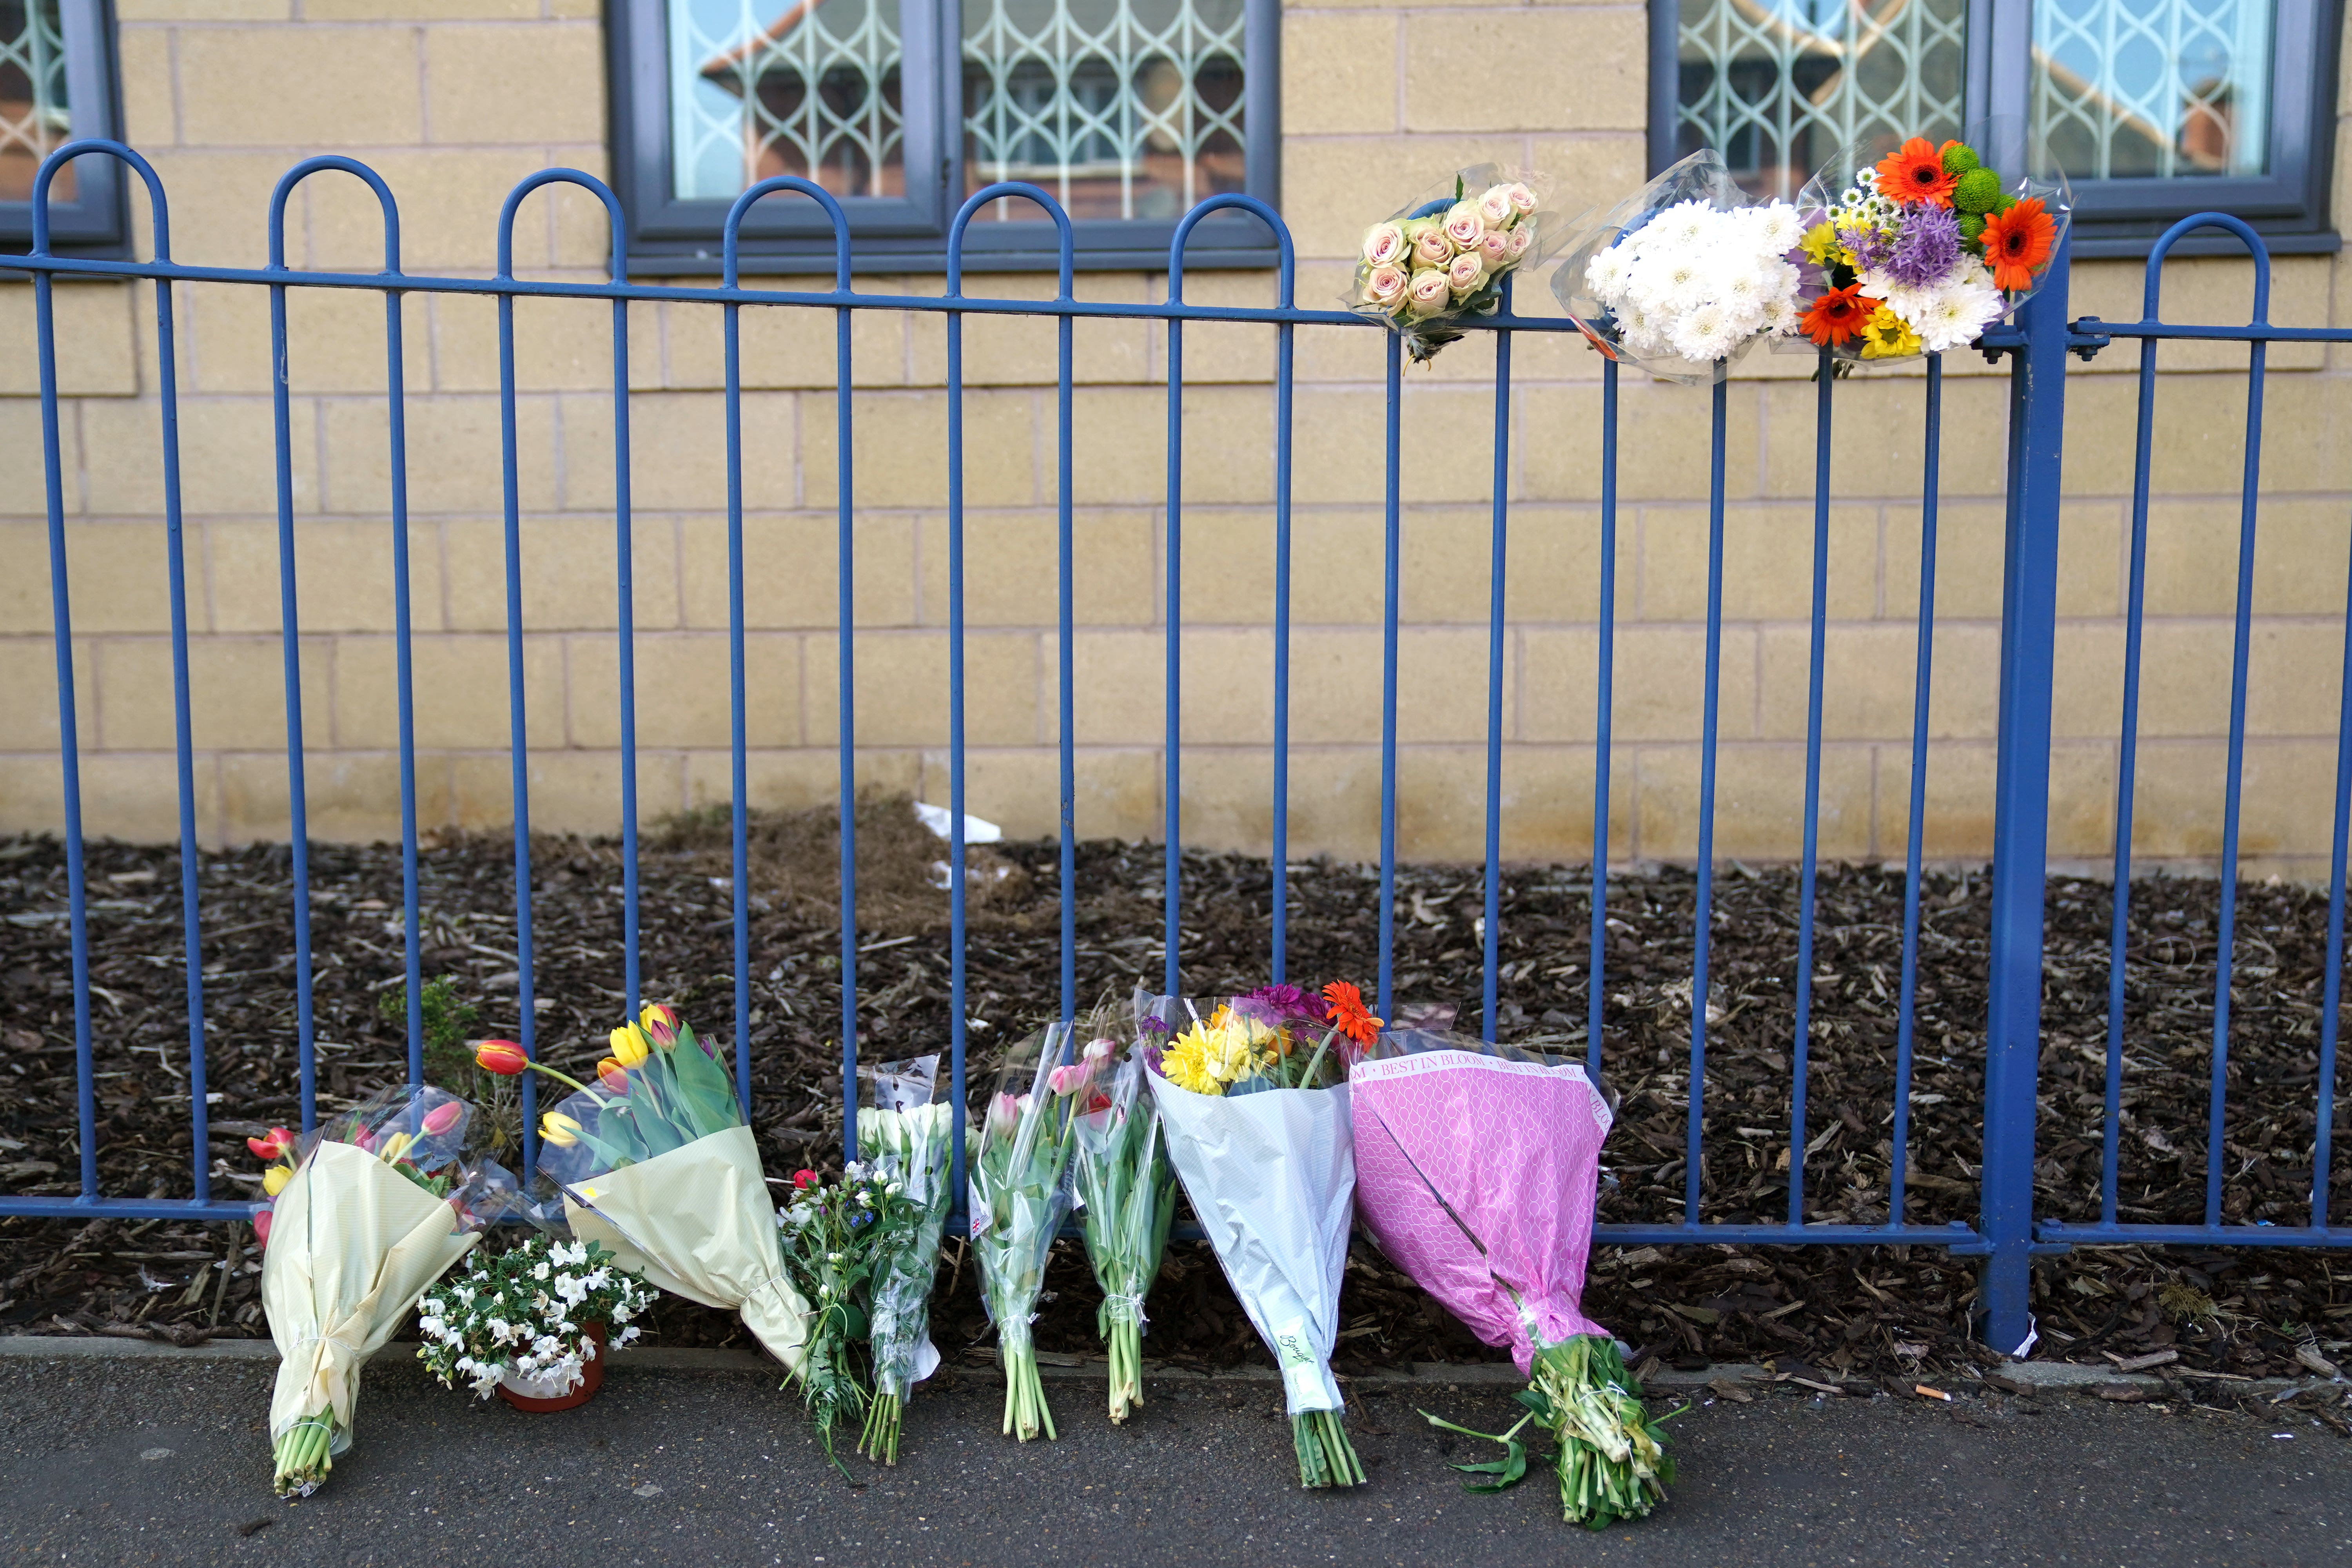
top-left (0, 799), bottom-right (2352, 1392)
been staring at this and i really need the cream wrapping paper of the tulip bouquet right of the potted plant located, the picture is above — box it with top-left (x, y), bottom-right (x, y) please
top-left (564, 1126), bottom-right (809, 1377)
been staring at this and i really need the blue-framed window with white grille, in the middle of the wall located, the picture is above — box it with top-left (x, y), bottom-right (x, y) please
top-left (626, 0), bottom-right (1279, 266)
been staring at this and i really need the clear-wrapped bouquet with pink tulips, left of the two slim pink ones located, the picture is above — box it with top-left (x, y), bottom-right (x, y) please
top-left (967, 1023), bottom-right (1087, 1443)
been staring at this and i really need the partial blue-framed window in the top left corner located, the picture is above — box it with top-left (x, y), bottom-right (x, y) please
top-left (0, 0), bottom-right (122, 252)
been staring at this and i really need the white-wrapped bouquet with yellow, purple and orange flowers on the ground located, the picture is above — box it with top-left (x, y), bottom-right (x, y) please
top-left (1148, 983), bottom-right (1381, 1486)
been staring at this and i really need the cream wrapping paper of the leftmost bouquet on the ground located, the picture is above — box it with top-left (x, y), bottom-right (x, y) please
top-left (261, 1140), bottom-right (482, 1453)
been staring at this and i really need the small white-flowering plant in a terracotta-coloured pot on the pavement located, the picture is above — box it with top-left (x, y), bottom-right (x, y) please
top-left (416, 1236), bottom-right (654, 1410)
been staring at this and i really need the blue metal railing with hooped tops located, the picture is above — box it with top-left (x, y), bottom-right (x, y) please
top-left (0, 141), bottom-right (2352, 1347)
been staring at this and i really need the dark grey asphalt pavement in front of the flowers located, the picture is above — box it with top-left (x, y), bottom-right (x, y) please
top-left (0, 1352), bottom-right (2352, 1568)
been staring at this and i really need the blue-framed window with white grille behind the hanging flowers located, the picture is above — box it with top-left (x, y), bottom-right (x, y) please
top-left (1651, 0), bottom-right (2343, 256)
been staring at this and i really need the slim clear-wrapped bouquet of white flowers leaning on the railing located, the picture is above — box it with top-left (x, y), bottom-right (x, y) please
top-left (858, 1056), bottom-right (955, 1465)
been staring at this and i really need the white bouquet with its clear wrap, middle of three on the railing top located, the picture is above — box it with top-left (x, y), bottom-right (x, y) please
top-left (1552, 148), bottom-right (1804, 383)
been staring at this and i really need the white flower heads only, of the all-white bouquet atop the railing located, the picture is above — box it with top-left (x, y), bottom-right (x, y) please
top-left (1583, 198), bottom-right (1804, 367)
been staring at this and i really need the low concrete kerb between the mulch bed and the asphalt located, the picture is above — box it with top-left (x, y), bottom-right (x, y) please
top-left (0, 1333), bottom-right (2340, 1401)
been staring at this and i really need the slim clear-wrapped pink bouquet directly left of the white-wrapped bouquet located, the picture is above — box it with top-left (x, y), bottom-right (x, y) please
top-left (1073, 992), bottom-right (1176, 1422)
